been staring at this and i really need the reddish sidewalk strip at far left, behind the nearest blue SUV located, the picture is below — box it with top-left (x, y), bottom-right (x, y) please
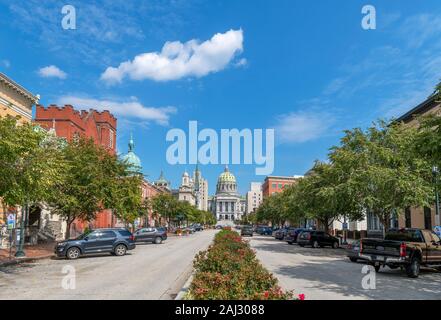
top-left (0, 243), bottom-right (55, 267)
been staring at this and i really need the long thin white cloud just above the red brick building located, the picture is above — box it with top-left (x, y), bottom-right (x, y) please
top-left (57, 96), bottom-right (177, 126)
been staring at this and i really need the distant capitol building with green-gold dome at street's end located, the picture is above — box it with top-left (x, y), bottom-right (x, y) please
top-left (208, 166), bottom-right (246, 225)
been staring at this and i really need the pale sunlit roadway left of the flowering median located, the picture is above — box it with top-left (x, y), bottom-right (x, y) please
top-left (0, 230), bottom-right (216, 300)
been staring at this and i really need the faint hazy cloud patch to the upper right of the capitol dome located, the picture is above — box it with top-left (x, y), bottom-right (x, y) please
top-left (275, 112), bottom-right (333, 143)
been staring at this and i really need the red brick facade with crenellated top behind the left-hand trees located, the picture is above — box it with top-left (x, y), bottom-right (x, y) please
top-left (35, 105), bottom-right (117, 236)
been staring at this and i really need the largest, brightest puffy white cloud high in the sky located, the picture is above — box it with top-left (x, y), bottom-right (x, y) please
top-left (101, 30), bottom-right (243, 83)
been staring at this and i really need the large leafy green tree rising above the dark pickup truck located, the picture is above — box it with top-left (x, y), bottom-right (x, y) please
top-left (330, 121), bottom-right (432, 229)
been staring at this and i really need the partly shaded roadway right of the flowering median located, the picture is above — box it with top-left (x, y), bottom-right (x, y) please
top-left (250, 236), bottom-right (441, 300)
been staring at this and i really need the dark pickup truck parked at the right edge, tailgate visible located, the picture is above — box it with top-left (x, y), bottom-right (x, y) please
top-left (359, 229), bottom-right (441, 278)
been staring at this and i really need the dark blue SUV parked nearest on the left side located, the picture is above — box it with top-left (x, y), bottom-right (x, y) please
top-left (55, 228), bottom-right (136, 260)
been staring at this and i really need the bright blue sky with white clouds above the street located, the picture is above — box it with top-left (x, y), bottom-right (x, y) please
top-left (0, 0), bottom-right (441, 193)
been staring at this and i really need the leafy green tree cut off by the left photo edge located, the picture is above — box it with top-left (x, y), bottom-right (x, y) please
top-left (0, 117), bottom-right (66, 221)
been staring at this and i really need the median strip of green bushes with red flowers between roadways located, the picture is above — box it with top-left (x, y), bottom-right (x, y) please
top-left (187, 230), bottom-right (292, 300)
